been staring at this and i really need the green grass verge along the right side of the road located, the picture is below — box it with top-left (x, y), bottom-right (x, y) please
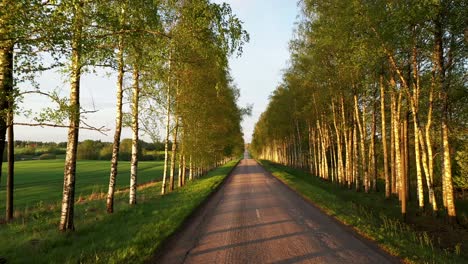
top-left (260, 160), bottom-right (468, 263)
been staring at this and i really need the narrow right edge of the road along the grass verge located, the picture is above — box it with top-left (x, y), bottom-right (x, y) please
top-left (255, 159), bottom-right (405, 263)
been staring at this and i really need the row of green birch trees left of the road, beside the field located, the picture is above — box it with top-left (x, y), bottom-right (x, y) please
top-left (0, 0), bottom-right (249, 231)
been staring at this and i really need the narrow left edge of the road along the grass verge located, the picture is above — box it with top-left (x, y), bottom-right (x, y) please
top-left (144, 158), bottom-right (243, 264)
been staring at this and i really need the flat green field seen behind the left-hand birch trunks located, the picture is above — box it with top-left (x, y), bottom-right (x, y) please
top-left (0, 159), bottom-right (164, 212)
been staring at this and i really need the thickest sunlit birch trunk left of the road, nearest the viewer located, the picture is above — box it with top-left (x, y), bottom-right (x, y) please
top-left (59, 2), bottom-right (83, 231)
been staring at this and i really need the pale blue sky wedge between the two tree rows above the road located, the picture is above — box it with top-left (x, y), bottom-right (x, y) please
top-left (218, 0), bottom-right (299, 142)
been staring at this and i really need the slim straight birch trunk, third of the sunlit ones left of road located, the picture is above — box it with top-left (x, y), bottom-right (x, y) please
top-left (129, 65), bottom-right (140, 205)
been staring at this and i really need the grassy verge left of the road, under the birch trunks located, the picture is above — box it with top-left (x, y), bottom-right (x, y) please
top-left (0, 161), bottom-right (236, 263)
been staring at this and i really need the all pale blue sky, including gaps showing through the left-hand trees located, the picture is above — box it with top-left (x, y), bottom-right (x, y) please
top-left (15, 0), bottom-right (299, 142)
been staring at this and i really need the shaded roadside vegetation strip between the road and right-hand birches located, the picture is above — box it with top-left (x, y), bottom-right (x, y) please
top-left (260, 160), bottom-right (468, 263)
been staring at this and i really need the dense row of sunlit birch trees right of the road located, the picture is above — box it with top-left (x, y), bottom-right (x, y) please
top-left (252, 0), bottom-right (468, 222)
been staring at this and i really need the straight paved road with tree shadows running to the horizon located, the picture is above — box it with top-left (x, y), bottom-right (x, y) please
top-left (153, 159), bottom-right (395, 264)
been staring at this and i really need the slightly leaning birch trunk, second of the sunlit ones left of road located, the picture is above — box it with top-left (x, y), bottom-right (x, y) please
top-left (106, 33), bottom-right (124, 213)
